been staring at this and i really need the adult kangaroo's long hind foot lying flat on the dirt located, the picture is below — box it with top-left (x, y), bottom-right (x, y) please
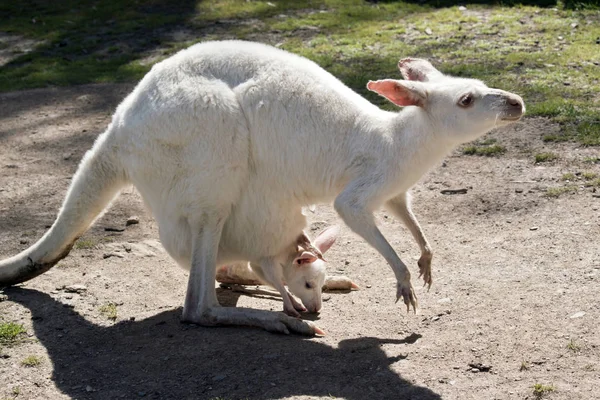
top-left (188, 307), bottom-right (325, 336)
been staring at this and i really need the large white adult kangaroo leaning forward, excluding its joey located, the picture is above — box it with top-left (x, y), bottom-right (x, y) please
top-left (0, 41), bottom-right (525, 335)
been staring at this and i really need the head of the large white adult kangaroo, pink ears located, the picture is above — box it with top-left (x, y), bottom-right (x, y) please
top-left (367, 58), bottom-right (525, 144)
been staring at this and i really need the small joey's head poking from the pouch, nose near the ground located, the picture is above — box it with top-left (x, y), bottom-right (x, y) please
top-left (284, 226), bottom-right (339, 312)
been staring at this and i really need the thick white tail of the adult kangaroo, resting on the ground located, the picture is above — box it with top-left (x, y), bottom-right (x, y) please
top-left (0, 126), bottom-right (128, 287)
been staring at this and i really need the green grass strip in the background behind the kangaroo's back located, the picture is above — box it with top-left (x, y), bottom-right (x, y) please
top-left (0, 0), bottom-right (600, 146)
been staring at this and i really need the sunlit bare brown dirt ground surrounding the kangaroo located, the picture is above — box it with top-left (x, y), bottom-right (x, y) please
top-left (0, 79), bottom-right (600, 400)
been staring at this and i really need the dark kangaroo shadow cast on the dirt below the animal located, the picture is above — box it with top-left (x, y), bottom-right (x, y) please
top-left (5, 288), bottom-right (441, 400)
